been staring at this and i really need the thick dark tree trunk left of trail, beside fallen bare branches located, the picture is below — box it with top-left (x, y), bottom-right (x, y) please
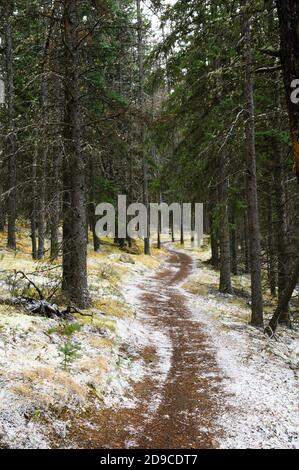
top-left (63, 0), bottom-right (89, 308)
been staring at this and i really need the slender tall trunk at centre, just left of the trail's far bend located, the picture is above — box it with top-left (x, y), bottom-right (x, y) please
top-left (136, 0), bottom-right (151, 255)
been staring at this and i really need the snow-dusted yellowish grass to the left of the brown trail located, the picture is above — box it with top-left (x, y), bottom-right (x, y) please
top-left (0, 246), bottom-right (169, 448)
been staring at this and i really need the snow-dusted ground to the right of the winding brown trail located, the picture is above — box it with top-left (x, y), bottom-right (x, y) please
top-left (186, 248), bottom-right (299, 449)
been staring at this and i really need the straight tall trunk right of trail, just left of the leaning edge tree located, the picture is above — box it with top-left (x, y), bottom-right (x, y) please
top-left (242, 0), bottom-right (264, 326)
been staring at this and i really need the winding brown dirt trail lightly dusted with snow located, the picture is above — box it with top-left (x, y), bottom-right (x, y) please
top-left (67, 252), bottom-right (221, 449)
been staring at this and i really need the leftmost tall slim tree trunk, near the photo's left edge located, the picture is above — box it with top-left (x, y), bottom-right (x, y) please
top-left (5, 0), bottom-right (17, 250)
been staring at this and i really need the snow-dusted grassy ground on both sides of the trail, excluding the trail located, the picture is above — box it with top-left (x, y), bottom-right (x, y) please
top-left (0, 241), bottom-right (299, 449)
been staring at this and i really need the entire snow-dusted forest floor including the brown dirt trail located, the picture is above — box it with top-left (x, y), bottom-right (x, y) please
top-left (0, 231), bottom-right (299, 448)
